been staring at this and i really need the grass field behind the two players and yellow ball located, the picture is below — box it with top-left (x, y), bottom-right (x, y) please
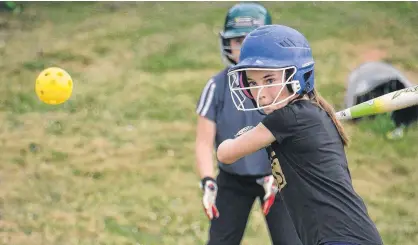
top-left (0, 2), bottom-right (418, 245)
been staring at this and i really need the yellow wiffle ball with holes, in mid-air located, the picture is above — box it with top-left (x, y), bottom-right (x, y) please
top-left (35, 67), bottom-right (73, 105)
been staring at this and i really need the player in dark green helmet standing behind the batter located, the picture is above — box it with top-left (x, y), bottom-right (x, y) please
top-left (195, 3), bottom-right (301, 245)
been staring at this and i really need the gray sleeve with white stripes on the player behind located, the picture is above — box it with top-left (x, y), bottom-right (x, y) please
top-left (196, 79), bottom-right (218, 121)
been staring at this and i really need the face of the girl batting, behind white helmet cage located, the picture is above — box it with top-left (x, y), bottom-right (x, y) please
top-left (246, 70), bottom-right (293, 114)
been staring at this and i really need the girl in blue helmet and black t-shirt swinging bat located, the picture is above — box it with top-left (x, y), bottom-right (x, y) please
top-left (217, 25), bottom-right (383, 245)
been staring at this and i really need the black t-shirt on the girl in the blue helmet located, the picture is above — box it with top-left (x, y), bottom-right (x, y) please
top-left (262, 100), bottom-right (383, 245)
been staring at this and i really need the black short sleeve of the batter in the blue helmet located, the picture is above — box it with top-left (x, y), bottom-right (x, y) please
top-left (261, 106), bottom-right (297, 144)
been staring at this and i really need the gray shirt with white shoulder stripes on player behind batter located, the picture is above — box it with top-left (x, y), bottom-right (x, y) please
top-left (196, 68), bottom-right (271, 175)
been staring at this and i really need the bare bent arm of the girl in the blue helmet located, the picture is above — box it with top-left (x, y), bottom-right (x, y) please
top-left (217, 123), bottom-right (276, 164)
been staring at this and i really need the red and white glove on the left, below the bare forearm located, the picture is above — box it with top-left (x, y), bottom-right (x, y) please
top-left (200, 177), bottom-right (219, 220)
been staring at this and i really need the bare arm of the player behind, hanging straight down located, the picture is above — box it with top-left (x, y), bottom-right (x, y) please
top-left (195, 116), bottom-right (216, 178)
